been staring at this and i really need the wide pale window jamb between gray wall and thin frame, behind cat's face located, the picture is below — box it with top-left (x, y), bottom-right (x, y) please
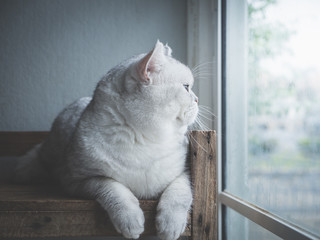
top-left (187, 0), bottom-right (219, 129)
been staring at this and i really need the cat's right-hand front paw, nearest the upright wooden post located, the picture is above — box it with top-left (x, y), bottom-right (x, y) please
top-left (156, 207), bottom-right (188, 240)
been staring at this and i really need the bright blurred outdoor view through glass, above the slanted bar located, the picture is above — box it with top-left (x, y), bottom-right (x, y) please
top-left (246, 0), bottom-right (320, 234)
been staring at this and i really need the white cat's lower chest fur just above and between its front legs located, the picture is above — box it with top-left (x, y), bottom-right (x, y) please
top-left (106, 143), bottom-right (185, 198)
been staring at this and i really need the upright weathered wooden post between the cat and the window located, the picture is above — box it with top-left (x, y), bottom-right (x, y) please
top-left (190, 131), bottom-right (217, 240)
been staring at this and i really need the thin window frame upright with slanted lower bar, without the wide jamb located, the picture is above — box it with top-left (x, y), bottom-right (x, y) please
top-left (217, 0), bottom-right (318, 239)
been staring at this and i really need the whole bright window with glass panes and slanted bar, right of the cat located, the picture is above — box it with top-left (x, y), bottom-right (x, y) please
top-left (220, 0), bottom-right (320, 239)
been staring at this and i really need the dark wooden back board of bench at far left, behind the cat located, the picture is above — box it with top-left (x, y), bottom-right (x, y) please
top-left (0, 132), bottom-right (48, 156)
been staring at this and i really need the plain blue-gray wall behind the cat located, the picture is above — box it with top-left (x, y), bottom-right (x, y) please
top-left (0, 0), bottom-right (187, 131)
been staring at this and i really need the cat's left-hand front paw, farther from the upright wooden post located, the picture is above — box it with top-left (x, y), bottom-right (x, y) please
top-left (110, 201), bottom-right (144, 239)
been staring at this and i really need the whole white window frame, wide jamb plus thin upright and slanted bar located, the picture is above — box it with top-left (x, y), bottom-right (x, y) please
top-left (187, 0), bottom-right (318, 239)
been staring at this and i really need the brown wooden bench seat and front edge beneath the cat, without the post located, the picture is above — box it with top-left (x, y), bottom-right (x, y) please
top-left (0, 184), bottom-right (191, 238)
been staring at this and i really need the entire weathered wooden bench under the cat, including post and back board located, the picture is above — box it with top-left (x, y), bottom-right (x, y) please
top-left (0, 131), bottom-right (217, 240)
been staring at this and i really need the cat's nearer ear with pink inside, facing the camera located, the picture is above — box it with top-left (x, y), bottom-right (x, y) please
top-left (138, 40), bottom-right (166, 84)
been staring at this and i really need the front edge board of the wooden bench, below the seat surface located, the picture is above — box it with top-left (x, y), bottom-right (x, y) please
top-left (0, 208), bottom-right (190, 239)
